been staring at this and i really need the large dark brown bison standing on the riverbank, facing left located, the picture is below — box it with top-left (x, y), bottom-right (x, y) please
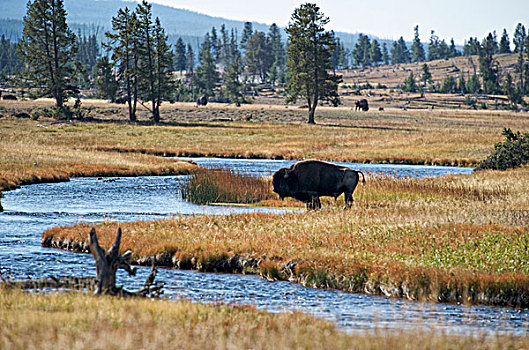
top-left (272, 160), bottom-right (365, 209)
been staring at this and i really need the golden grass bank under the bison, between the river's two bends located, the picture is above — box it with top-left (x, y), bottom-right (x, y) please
top-left (43, 168), bottom-right (529, 306)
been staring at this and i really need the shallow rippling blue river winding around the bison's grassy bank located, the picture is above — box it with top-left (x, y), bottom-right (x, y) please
top-left (0, 159), bottom-right (529, 334)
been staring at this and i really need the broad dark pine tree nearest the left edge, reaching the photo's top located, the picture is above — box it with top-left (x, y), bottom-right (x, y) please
top-left (18, 0), bottom-right (78, 109)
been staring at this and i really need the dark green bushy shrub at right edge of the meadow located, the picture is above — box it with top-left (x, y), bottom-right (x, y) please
top-left (476, 128), bottom-right (529, 170)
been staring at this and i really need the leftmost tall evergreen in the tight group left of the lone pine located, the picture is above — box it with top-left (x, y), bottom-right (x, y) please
top-left (105, 7), bottom-right (139, 122)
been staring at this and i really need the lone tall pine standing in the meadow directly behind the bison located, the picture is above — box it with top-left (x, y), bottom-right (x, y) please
top-left (287, 3), bottom-right (342, 124)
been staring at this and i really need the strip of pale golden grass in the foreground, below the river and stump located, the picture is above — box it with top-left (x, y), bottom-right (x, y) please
top-left (0, 288), bottom-right (529, 349)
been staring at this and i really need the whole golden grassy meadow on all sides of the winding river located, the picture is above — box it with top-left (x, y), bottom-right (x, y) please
top-left (0, 101), bottom-right (529, 349)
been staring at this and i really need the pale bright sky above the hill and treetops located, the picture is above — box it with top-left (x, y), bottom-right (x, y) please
top-left (140, 0), bottom-right (529, 44)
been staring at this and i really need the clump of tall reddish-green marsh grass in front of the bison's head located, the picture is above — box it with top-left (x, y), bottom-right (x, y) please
top-left (182, 169), bottom-right (277, 204)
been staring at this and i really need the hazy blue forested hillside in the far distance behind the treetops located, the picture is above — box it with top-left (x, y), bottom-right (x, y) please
top-left (0, 0), bottom-right (372, 49)
